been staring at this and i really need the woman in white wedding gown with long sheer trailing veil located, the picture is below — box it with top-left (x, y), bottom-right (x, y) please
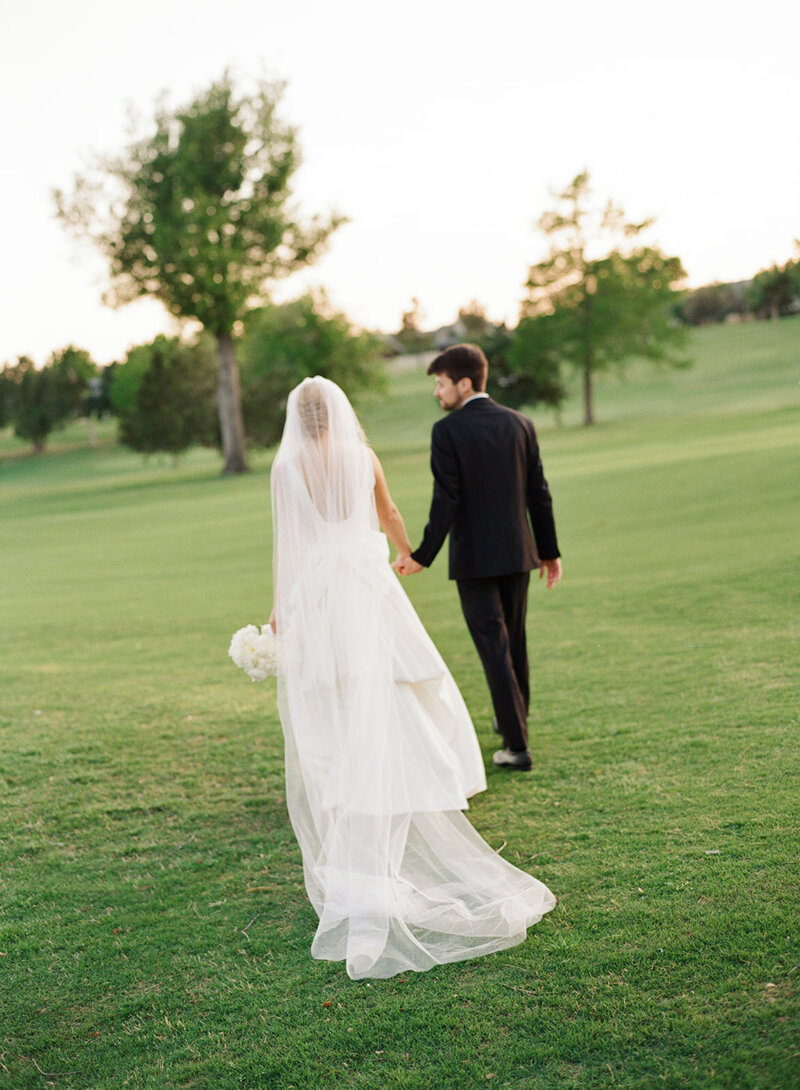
top-left (270, 377), bottom-right (556, 980)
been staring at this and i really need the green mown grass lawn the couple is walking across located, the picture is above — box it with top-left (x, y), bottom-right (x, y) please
top-left (0, 319), bottom-right (800, 1090)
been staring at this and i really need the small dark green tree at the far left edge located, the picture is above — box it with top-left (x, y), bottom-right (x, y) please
top-left (2, 346), bottom-right (97, 453)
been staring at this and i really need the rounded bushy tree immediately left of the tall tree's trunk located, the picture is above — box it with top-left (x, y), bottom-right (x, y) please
top-left (110, 335), bottom-right (219, 458)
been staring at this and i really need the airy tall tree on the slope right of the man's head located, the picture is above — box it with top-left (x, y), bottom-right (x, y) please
top-left (517, 172), bottom-right (688, 425)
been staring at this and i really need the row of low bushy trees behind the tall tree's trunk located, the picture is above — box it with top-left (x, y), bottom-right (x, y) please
top-left (0, 292), bottom-right (385, 456)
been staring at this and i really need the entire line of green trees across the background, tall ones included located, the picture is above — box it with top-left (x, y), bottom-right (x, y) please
top-left (0, 75), bottom-right (800, 455)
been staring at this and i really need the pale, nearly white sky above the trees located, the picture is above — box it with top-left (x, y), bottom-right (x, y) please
top-left (0, 0), bottom-right (800, 364)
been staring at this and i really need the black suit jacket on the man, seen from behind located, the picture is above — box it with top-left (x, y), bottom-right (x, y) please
top-left (411, 398), bottom-right (560, 579)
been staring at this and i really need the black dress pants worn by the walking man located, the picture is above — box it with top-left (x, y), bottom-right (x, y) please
top-left (457, 571), bottom-right (531, 750)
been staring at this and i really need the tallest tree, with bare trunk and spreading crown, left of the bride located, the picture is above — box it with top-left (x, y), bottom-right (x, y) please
top-left (54, 74), bottom-right (343, 473)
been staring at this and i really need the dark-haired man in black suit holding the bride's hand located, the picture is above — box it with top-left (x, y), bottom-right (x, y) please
top-left (392, 344), bottom-right (561, 772)
